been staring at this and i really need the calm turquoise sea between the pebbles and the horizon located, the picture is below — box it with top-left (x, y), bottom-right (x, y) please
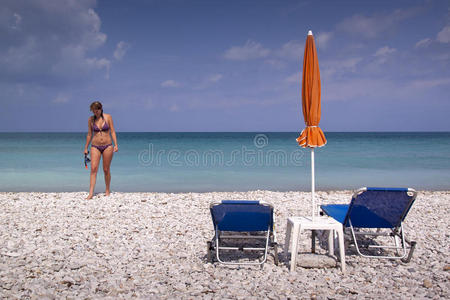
top-left (0, 132), bottom-right (450, 192)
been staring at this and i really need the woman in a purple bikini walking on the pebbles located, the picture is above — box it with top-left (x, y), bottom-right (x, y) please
top-left (84, 101), bottom-right (119, 199)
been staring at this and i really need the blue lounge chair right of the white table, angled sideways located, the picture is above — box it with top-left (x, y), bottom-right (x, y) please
top-left (321, 188), bottom-right (417, 262)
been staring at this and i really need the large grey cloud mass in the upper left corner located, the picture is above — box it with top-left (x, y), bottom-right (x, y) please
top-left (0, 0), bottom-right (110, 84)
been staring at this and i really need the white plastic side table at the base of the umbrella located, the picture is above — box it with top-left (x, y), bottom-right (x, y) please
top-left (284, 216), bottom-right (345, 273)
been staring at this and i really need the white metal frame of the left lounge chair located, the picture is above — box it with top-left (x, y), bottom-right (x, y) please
top-left (207, 200), bottom-right (278, 266)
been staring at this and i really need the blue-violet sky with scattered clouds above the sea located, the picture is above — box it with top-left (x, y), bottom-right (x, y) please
top-left (0, 0), bottom-right (450, 132)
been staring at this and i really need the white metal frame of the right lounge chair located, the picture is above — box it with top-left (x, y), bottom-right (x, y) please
top-left (325, 188), bottom-right (417, 263)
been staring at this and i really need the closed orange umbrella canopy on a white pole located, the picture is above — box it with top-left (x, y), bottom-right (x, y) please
top-left (297, 32), bottom-right (327, 148)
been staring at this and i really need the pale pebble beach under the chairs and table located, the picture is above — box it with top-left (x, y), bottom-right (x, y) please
top-left (0, 191), bottom-right (450, 299)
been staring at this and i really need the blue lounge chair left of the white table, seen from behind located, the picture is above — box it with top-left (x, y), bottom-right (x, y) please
top-left (207, 200), bottom-right (278, 266)
